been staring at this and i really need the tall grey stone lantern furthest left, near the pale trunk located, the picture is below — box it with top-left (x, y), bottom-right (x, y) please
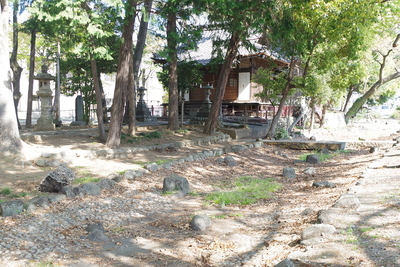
top-left (34, 65), bottom-right (55, 131)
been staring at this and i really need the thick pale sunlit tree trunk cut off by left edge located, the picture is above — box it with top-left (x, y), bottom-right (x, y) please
top-left (0, 0), bottom-right (22, 154)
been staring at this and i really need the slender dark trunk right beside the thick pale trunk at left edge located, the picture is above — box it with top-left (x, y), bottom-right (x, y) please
top-left (10, 1), bottom-right (22, 129)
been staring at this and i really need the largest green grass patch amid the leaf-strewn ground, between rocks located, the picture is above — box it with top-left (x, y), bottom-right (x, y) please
top-left (206, 177), bottom-right (282, 206)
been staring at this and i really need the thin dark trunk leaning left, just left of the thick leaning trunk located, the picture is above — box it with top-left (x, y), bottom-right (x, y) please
top-left (90, 54), bottom-right (107, 143)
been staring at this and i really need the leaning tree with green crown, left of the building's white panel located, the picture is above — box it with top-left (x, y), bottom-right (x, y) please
top-left (203, 0), bottom-right (276, 134)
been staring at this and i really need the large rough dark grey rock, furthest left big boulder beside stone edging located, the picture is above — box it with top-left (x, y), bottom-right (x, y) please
top-left (39, 166), bottom-right (75, 192)
